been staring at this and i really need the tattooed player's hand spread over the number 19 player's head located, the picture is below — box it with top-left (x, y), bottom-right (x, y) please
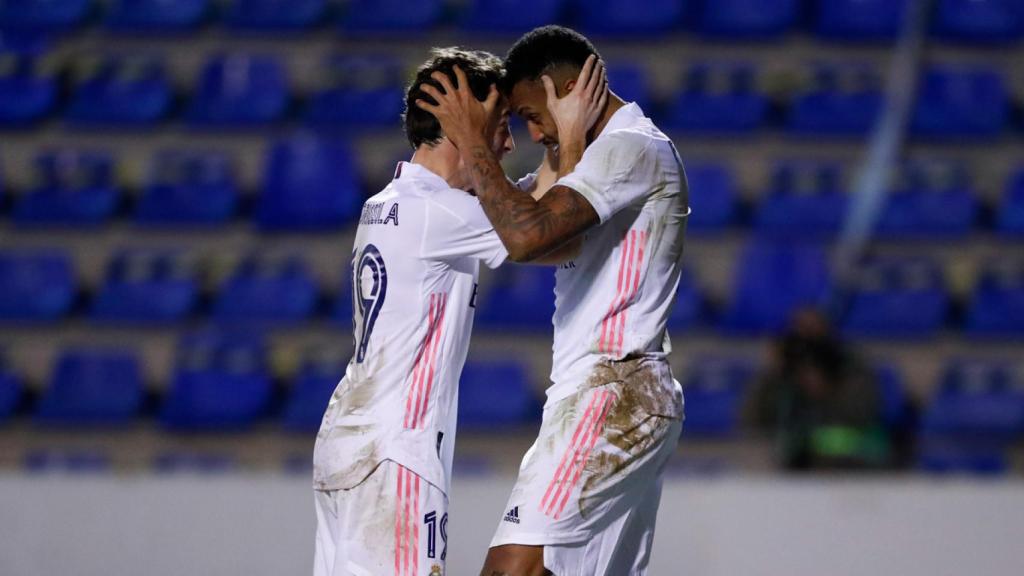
top-left (415, 66), bottom-right (501, 147)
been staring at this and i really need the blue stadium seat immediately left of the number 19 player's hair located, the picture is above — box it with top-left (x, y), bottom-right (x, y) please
top-left (305, 55), bottom-right (406, 128)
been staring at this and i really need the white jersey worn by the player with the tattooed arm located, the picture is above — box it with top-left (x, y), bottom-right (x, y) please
top-left (548, 104), bottom-right (689, 404)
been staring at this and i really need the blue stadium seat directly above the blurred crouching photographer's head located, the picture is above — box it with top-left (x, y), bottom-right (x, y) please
top-left (723, 239), bottom-right (831, 333)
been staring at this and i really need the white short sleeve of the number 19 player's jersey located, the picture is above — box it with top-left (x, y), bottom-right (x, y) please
top-left (423, 192), bottom-right (509, 269)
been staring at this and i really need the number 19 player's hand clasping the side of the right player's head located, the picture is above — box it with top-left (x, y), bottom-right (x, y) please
top-left (541, 54), bottom-right (608, 140)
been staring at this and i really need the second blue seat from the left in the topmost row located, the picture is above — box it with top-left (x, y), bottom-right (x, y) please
top-left (105, 0), bottom-right (211, 33)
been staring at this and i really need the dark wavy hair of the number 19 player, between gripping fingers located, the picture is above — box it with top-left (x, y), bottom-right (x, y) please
top-left (402, 46), bottom-right (502, 150)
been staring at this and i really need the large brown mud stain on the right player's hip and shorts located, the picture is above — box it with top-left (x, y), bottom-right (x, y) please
top-left (580, 358), bottom-right (682, 517)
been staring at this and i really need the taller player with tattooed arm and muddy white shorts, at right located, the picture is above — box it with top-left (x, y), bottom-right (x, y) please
top-left (417, 26), bottom-right (689, 576)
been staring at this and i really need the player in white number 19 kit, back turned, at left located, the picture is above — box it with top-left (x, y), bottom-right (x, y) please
top-left (313, 48), bottom-right (603, 576)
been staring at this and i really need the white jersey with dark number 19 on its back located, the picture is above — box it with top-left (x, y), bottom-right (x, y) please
top-left (313, 162), bottom-right (508, 493)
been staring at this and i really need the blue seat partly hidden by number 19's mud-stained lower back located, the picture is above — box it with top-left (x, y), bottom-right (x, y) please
top-left (283, 354), bottom-right (345, 431)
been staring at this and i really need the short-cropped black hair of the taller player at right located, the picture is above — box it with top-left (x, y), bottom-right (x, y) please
top-left (502, 25), bottom-right (601, 94)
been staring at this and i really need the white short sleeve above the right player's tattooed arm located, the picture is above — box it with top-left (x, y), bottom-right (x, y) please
top-left (555, 130), bottom-right (658, 223)
